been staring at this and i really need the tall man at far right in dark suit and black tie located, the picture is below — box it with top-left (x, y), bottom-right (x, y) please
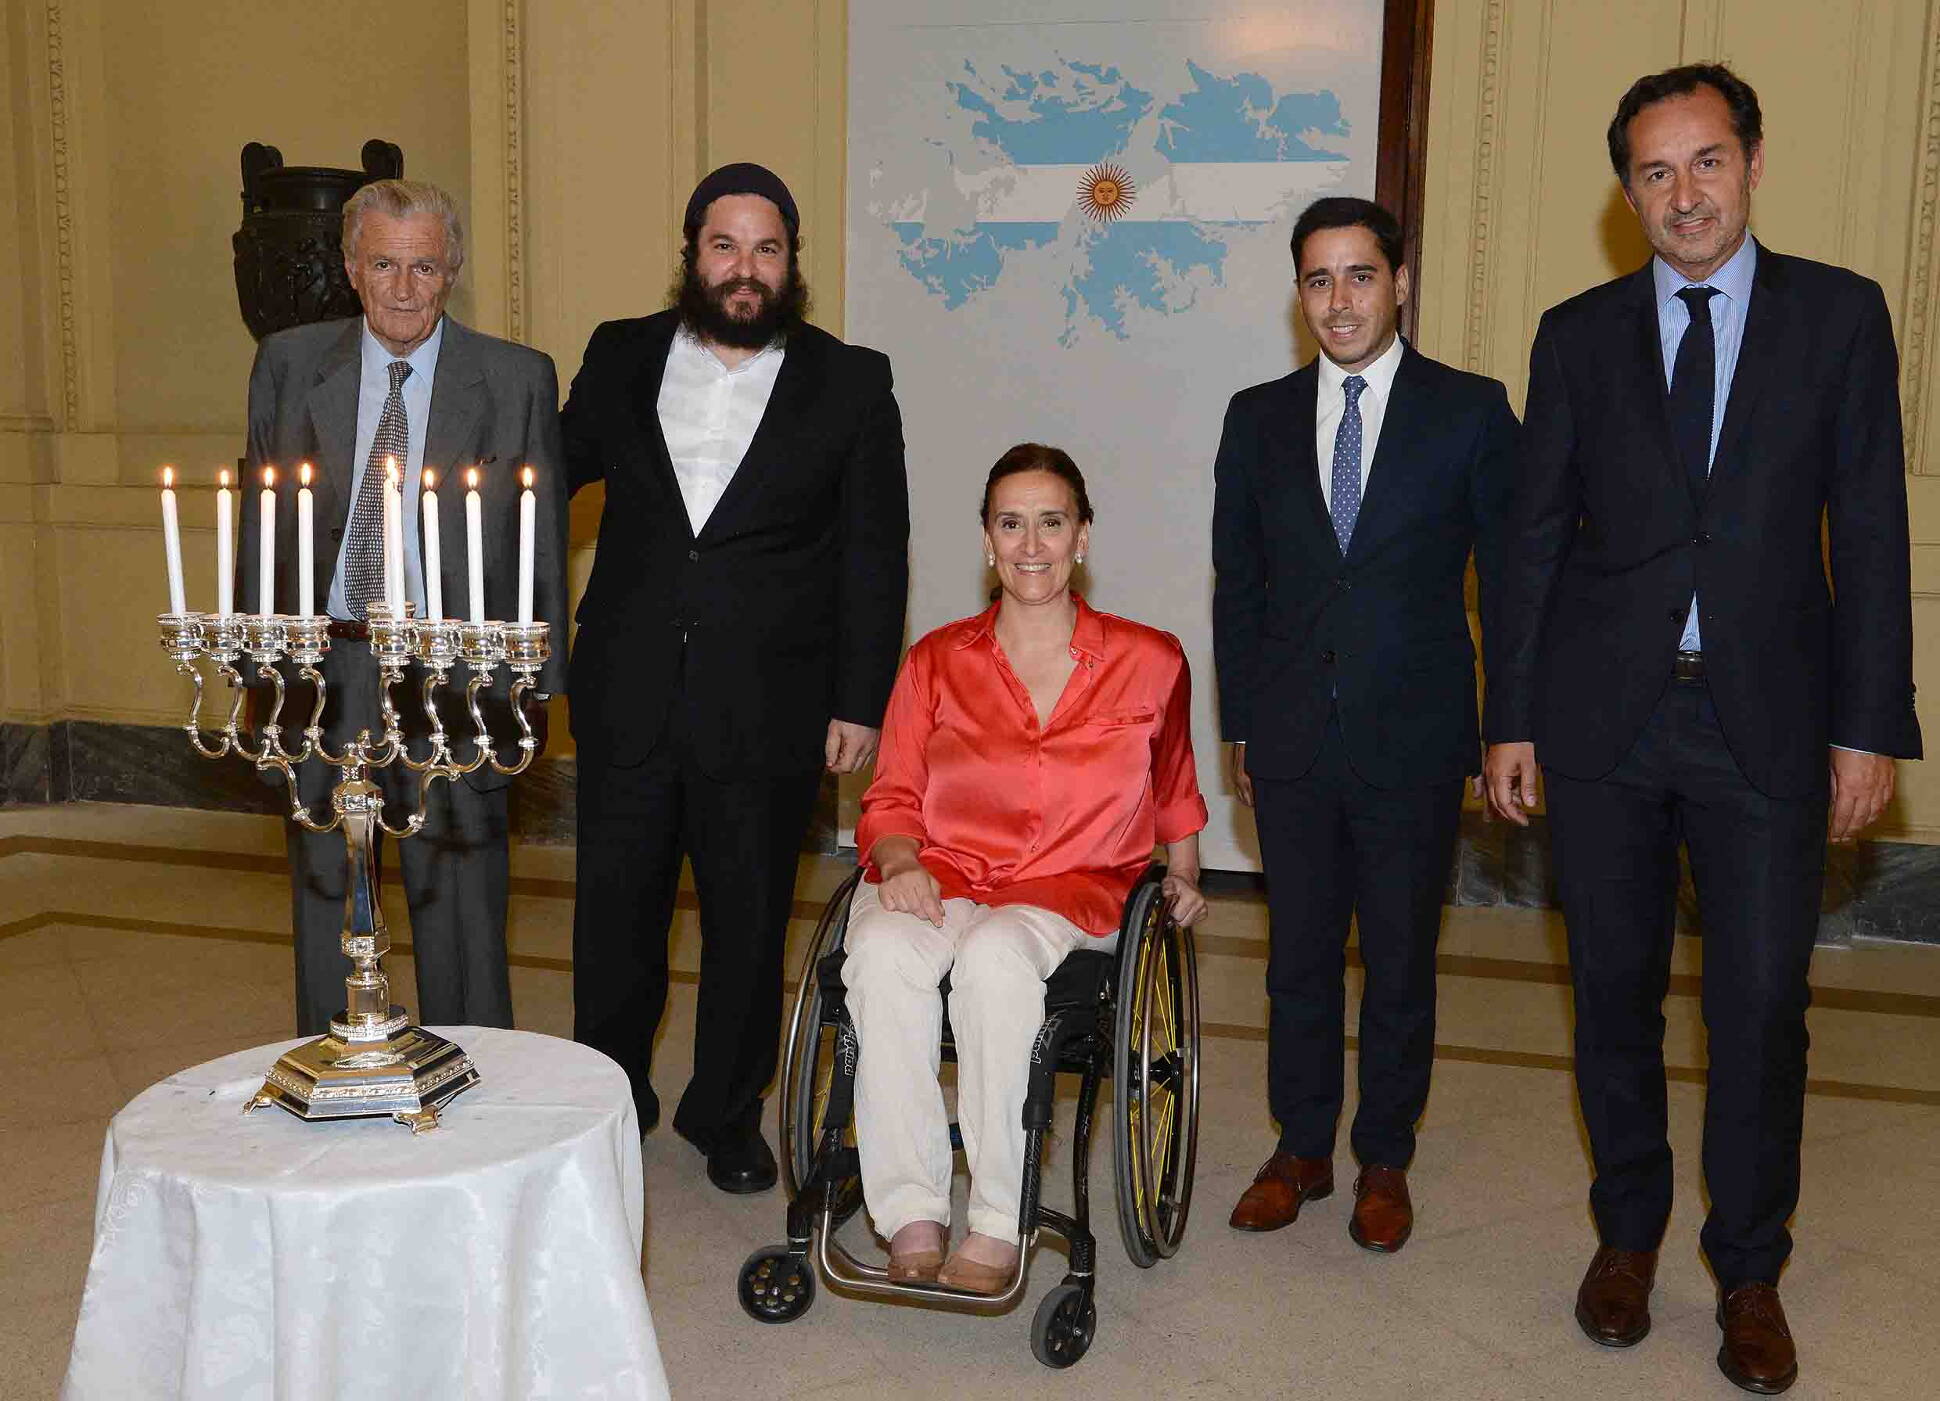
top-left (1486, 66), bottom-right (1921, 1391)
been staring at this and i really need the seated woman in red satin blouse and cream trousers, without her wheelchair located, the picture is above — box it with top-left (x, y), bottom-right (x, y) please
top-left (842, 442), bottom-right (1207, 1294)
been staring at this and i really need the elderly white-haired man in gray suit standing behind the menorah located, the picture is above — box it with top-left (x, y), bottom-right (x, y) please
top-left (237, 180), bottom-right (566, 1036)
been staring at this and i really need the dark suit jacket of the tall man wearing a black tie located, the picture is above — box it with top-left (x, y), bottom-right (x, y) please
top-left (1486, 246), bottom-right (1921, 783)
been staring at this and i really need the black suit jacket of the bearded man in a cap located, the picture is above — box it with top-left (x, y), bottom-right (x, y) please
top-left (563, 312), bottom-right (910, 778)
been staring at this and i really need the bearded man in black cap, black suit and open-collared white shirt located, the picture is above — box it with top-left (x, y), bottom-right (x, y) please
top-left (565, 165), bottom-right (910, 1191)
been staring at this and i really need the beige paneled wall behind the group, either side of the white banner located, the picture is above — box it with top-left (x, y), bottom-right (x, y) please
top-left (11, 0), bottom-right (1940, 840)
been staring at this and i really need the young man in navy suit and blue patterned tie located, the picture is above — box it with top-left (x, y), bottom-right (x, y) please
top-left (1213, 198), bottom-right (1515, 1252)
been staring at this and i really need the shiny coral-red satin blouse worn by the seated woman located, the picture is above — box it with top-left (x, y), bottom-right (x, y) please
top-left (856, 594), bottom-right (1207, 935)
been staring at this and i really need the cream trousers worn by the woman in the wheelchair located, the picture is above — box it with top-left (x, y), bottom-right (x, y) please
top-left (842, 881), bottom-right (1106, 1242)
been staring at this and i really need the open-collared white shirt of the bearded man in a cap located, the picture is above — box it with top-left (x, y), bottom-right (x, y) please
top-left (656, 326), bottom-right (784, 536)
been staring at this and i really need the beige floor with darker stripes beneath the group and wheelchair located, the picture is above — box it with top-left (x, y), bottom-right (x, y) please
top-left (0, 805), bottom-right (1940, 1399)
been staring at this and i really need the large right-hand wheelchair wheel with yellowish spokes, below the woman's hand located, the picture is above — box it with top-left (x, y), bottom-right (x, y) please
top-left (1112, 881), bottom-right (1199, 1269)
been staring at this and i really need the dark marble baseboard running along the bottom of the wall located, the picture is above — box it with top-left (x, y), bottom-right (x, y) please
top-left (0, 720), bottom-right (1940, 945)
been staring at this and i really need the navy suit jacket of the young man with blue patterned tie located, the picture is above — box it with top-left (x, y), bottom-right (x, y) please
top-left (1213, 345), bottom-right (1515, 788)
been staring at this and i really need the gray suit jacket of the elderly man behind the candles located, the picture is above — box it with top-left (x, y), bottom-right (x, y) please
top-left (237, 316), bottom-right (566, 693)
